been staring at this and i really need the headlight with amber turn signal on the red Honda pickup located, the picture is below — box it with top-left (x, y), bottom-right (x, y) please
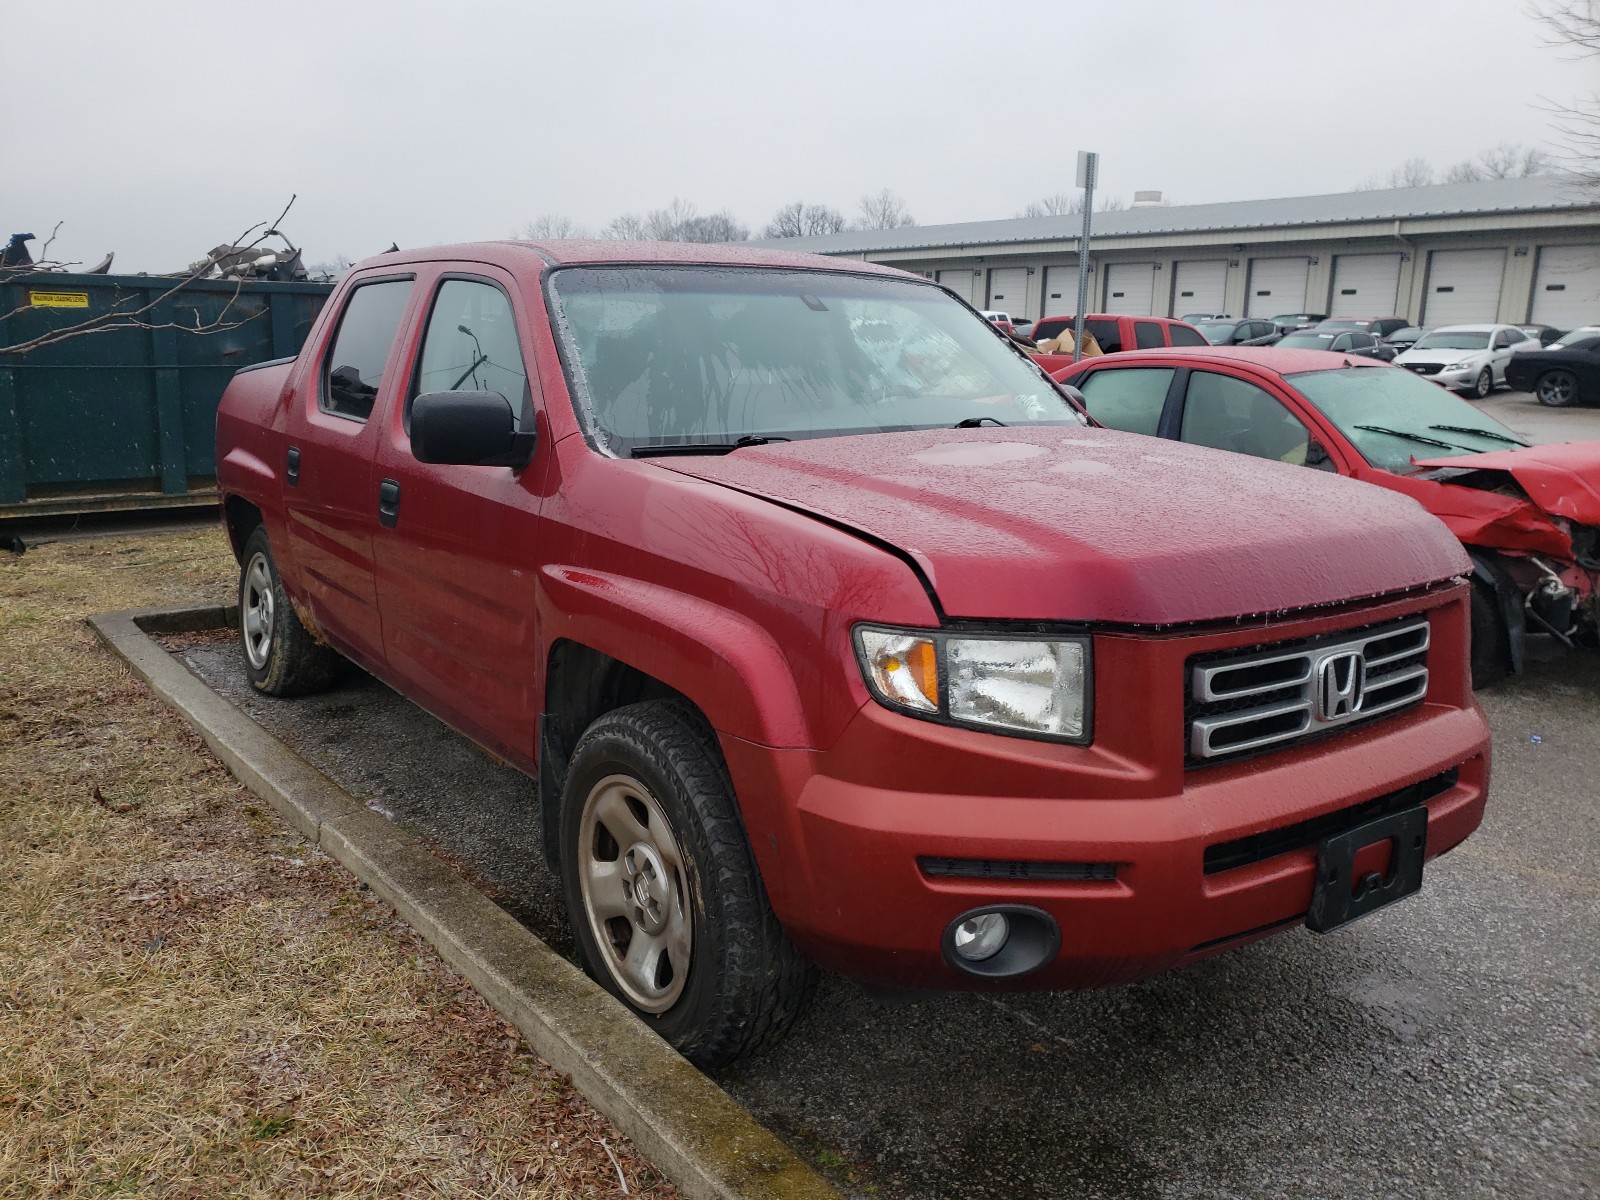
top-left (856, 626), bottom-right (1093, 742)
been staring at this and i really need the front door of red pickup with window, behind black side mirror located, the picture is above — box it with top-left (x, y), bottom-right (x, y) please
top-left (374, 266), bottom-right (549, 766)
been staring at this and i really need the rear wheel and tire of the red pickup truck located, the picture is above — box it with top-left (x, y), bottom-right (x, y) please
top-left (238, 525), bottom-right (342, 696)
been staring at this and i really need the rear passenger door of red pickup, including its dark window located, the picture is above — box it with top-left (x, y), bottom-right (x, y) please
top-left (283, 272), bottom-right (414, 666)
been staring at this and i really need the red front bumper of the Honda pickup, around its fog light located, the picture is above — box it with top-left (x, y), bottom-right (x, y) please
top-left (723, 597), bottom-right (1490, 989)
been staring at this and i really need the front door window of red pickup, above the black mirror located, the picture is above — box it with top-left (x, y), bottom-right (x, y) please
top-left (406, 278), bottom-right (533, 429)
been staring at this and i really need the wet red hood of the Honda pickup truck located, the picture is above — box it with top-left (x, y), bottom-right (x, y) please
top-left (653, 427), bottom-right (1470, 626)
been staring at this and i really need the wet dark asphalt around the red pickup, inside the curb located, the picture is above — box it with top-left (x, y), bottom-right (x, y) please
top-left (175, 633), bottom-right (1600, 1200)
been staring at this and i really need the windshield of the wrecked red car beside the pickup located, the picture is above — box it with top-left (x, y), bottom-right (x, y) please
top-left (1286, 366), bottom-right (1528, 475)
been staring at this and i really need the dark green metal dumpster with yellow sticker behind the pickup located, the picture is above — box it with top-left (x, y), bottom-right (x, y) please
top-left (0, 272), bottom-right (333, 518)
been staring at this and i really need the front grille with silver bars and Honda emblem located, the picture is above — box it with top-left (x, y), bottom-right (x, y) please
top-left (1184, 618), bottom-right (1429, 766)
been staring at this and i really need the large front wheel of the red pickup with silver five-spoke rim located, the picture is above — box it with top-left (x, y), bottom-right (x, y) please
top-left (562, 701), bottom-right (818, 1067)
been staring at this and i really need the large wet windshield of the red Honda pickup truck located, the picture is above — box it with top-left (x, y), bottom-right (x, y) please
top-left (550, 267), bottom-right (1083, 454)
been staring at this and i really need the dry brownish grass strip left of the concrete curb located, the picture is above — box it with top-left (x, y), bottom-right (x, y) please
top-left (0, 530), bottom-right (674, 1200)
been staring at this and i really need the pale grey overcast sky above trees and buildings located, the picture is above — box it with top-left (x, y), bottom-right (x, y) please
top-left (0, 0), bottom-right (1600, 272)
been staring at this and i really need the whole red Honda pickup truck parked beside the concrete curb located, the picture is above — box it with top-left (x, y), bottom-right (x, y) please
top-left (218, 242), bottom-right (1490, 1064)
